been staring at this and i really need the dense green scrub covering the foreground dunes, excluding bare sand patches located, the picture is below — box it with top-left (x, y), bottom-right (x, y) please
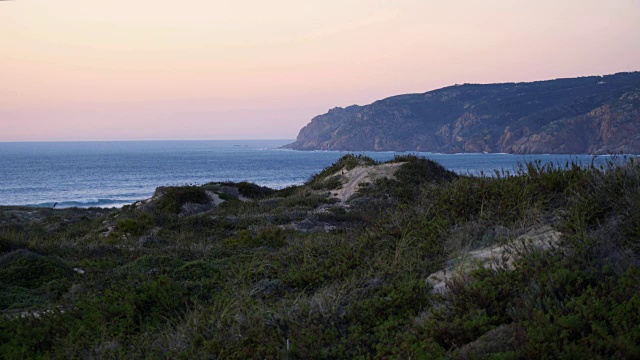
top-left (0, 155), bottom-right (640, 359)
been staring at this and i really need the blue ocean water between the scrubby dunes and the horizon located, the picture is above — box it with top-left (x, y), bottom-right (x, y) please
top-left (0, 140), bottom-right (620, 208)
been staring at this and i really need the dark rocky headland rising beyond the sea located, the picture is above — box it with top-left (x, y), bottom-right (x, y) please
top-left (284, 72), bottom-right (640, 154)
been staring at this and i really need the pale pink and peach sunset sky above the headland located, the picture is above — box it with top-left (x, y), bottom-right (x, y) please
top-left (0, 0), bottom-right (640, 141)
